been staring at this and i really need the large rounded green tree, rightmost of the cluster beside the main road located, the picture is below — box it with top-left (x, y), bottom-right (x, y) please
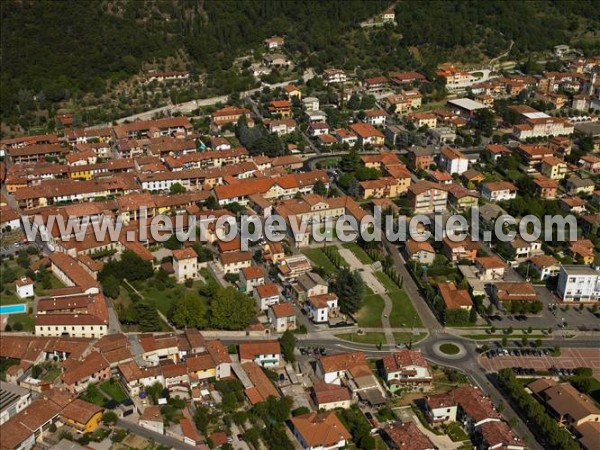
top-left (210, 286), bottom-right (256, 330)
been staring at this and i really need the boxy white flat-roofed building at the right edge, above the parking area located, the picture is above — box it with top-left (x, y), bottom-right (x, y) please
top-left (556, 265), bottom-right (600, 302)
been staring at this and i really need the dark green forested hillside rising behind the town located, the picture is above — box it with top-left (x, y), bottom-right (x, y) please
top-left (0, 0), bottom-right (600, 126)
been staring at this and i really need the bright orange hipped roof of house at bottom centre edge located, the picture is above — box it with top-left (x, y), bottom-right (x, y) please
top-left (290, 412), bottom-right (351, 448)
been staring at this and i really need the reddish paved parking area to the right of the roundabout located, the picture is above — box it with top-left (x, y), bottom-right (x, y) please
top-left (479, 348), bottom-right (600, 377)
